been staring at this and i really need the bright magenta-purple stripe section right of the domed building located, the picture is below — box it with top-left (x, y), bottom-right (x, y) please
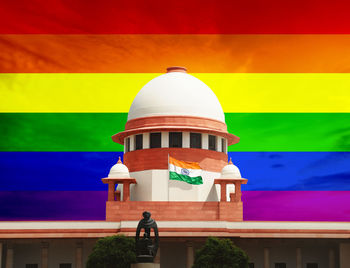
top-left (242, 191), bottom-right (350, 221)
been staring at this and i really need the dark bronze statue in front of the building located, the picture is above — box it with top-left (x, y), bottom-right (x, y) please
top-left (136, 211), bottom-right (159, 263)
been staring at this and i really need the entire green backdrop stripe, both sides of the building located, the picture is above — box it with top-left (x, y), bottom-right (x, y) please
top-left (0, 113), bottom-right (350, 152)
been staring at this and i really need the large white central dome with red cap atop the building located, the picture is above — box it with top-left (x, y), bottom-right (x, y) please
top-left (128, 67), bottom-right (225, 122)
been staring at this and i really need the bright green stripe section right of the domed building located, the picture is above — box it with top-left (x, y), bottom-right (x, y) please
top-left (226, 113), bottom-right (350, 152)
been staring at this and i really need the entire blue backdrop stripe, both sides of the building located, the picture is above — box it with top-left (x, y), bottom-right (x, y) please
top-left (0, 152), bottom-right (350, 191)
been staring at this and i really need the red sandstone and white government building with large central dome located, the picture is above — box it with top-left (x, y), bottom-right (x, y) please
top-left (0, 67), bottom-right (350, 268)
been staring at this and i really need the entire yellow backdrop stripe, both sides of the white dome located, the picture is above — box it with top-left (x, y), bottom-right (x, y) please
top-left (0, 73), bottom-right (350, 112)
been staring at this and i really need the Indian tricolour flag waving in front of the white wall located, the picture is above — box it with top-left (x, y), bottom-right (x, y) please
top-left (169, 156), bottom-right (203, 185)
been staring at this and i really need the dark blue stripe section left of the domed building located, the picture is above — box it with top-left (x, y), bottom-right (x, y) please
top-left (0, 152), bottom-right (122, 191)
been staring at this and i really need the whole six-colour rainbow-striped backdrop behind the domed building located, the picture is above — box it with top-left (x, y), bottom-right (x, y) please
top-left (0, 0), bottom-right (350, 221)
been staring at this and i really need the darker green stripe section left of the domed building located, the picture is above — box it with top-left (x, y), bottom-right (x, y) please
top-left (0, 113), bottom-right (127, 152)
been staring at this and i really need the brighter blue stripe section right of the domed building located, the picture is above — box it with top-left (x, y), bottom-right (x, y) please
top-left (229, 152), bottom-right (350, 191)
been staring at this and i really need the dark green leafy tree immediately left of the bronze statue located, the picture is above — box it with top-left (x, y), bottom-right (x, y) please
top-left (86, 235), bottom-right (136, 268)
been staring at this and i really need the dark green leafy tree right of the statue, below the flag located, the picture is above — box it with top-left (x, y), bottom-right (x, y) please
top-left (192, 237), bottom-right (248, 268)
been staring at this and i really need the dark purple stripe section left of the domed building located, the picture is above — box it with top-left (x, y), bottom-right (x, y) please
top-left (0, 191), bottom-right (107, 221)
